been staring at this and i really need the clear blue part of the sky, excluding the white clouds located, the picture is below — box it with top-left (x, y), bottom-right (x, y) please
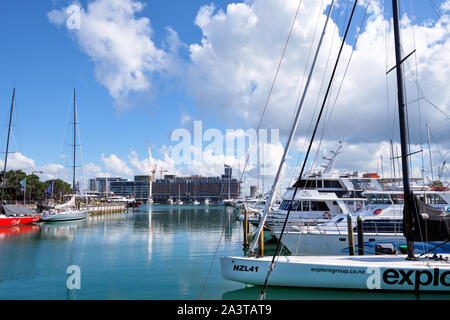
top-left (0, 0), bottom-right (448, 190)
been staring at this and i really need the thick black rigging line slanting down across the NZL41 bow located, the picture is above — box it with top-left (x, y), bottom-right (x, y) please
top-left (259, 0), bottom-right (358, 300)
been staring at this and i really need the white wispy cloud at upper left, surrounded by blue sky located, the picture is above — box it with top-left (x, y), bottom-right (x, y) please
top-left (48, 0), bottom-right (166, 108)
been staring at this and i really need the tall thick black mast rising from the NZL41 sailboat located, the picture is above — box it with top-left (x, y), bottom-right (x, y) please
top-left (392, 0), bottom-right (415, 259)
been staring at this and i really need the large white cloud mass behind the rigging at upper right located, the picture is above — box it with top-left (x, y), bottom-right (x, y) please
top-left (184, 0), bottom-right (450, 178)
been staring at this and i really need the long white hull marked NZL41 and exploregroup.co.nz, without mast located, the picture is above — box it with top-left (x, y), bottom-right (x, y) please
top-left (220, 255), bottom-right (450, 292)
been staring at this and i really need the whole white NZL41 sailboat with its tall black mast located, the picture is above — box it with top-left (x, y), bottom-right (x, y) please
top-left (221, 0), bottom-right (450, 299)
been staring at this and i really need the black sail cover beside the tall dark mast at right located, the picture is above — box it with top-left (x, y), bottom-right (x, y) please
top-left (403, 195), bottom-right (450, 242)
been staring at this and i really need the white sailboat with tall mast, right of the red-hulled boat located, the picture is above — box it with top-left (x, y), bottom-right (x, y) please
top-left (41, 89), bottom-right (88, 222)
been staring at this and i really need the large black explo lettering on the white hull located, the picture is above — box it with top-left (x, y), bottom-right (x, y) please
top-left (383, 268), bottom-right (450, 290)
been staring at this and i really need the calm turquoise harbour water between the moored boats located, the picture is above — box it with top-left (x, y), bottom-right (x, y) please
top-left (0, 205), bottom-right (450, 300)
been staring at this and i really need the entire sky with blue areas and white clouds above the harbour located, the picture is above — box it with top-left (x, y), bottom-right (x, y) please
top-left (0, 0), bottom-right (450, 191)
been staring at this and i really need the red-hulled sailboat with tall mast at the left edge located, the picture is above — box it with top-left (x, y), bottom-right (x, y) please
top-left (0, 88), bottom-right (41, 227)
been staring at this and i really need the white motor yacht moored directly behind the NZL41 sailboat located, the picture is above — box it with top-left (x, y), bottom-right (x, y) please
top-left (272, 188), bottom-right (450, 255)
